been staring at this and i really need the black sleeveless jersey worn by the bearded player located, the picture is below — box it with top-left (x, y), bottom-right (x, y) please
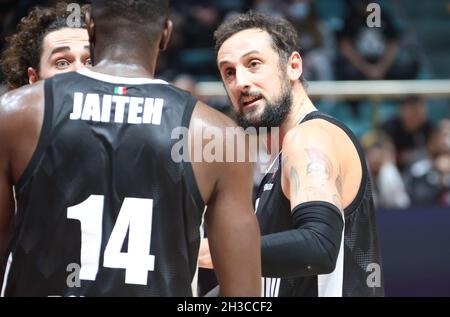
top-left (255, 111), bottom-right (384, 297)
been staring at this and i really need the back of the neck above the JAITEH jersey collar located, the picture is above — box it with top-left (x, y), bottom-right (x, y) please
top-left (92, 43), bottom-right (157, 78)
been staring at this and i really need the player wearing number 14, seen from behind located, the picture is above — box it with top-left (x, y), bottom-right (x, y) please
top-left (0, 0), bottom-right (261, 296)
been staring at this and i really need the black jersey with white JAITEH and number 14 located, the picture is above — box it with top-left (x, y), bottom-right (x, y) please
top-left (4, 70), bottom-right (204, 296)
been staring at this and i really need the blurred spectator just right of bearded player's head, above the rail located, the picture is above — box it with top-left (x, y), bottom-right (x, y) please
top-left (285, 0), bottom-right (335, 80)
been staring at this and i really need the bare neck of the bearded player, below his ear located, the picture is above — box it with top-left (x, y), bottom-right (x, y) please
top-left (267, 82), bottom-right (317, 153)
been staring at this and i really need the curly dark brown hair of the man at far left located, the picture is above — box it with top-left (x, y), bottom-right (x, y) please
top-left (0, 2), bottom-right (88, 90)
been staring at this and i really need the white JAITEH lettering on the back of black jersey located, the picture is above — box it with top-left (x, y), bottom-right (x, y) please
top-left (70, 92), bottom-right (164, 125)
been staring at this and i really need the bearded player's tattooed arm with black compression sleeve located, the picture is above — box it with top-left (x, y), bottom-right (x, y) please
top-left (261, 123), bottom-right (343, 277)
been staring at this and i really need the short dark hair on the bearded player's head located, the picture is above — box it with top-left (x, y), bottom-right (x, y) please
top-left (214, 11), bottom-right (305, 83)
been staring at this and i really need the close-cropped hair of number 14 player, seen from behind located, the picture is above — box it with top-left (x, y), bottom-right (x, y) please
top-left (91, 0), bottom-right (169, 41)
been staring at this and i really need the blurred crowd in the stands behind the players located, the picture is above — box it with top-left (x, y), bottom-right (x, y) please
top-left (0, 0), bottom-right (450, 208)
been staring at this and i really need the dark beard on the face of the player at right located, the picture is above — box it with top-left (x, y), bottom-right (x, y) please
top-left (235, 83), bottom-right (292, 129)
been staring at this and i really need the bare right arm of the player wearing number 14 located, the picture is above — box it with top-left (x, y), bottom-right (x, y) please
top-left (190, 104), bottom-right (261, 296)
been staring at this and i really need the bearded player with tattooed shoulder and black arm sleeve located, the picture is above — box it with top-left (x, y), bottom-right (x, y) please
top-left (202, 12), bottom-right (383, 296)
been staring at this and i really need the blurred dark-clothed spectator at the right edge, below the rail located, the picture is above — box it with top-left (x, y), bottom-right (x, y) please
top-left (405, 119), bottom-right (450, 206)
